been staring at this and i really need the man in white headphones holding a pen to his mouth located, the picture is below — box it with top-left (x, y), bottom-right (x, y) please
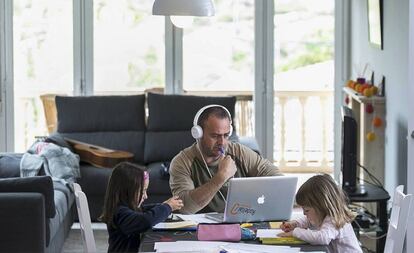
top-left (170, 105), bottom-right (282, 213)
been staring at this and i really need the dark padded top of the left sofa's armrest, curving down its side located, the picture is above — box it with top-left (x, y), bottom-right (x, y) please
top-left (0, 176), bottom-right (56, 218)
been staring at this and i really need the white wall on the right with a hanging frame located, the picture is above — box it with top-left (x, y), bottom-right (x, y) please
top-left (350, 0), bottom-right (409, 195)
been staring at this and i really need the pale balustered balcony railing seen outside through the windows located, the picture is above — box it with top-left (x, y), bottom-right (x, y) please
top-left (16, 91), bottom-right (333, 173)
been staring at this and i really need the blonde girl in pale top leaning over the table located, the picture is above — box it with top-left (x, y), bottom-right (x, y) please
top-left (279, 174), bottom-right (362, 252)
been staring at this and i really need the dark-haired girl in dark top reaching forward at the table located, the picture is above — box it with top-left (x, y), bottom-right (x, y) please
top-left (100, 162), bottom-right (183, 252)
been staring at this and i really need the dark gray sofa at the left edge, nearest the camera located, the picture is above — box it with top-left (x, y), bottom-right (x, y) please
top-left (0, 174), bottom-right (76, 253)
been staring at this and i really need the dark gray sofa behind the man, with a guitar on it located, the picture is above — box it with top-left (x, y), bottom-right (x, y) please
top-left (55, 93), bottom-right (249, 220)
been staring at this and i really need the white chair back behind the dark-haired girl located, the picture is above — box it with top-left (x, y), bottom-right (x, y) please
top-left (73, 183), bottom-right (96, 253)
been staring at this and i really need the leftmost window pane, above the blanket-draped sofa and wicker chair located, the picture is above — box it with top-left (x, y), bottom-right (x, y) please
top-left (13, 0), bottom-right (73, 152)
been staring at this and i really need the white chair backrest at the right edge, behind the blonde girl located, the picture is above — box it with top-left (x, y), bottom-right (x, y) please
top-left (384, 185), bottom-right (412, 253)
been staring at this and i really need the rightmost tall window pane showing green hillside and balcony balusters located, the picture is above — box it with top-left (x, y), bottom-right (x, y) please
top-left (274, 0), bottom-right (334, 172)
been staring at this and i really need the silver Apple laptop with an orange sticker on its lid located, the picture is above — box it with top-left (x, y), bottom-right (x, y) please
top-left (205, 176), bottom-right (298, 223)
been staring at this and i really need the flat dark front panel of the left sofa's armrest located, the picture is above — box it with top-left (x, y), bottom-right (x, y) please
top-left (0, 192), bottom-right (46, 252)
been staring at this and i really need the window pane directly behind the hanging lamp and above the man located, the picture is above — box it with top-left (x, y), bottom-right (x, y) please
top-left (183, 0), bottom-right (254, 136)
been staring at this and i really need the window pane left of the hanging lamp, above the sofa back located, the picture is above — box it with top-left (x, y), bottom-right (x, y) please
top-left (93, 0), bottom-right (165, 94)
